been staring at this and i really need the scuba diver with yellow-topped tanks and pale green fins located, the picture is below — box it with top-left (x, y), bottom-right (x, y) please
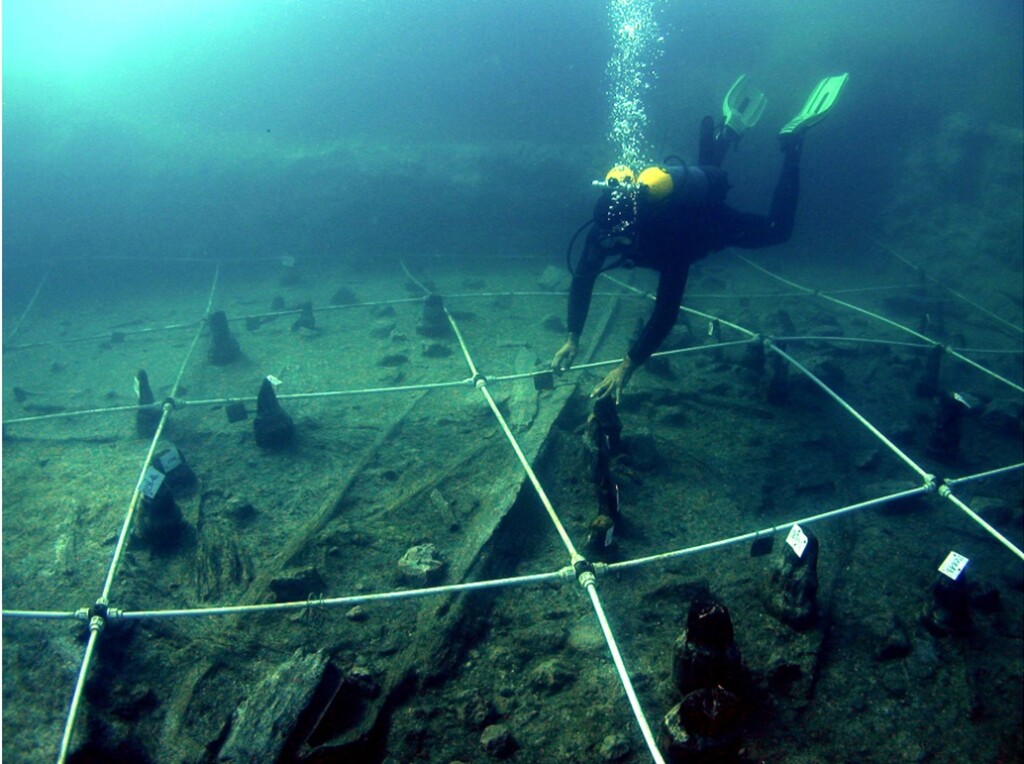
top-left (551, 74), bottom-right (848, 402)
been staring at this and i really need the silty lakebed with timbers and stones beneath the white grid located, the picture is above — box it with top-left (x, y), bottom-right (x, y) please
top-left (3, 240), bottom-right (1024, 762)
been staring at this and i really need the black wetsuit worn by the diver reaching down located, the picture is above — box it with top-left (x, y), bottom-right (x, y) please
top-left (566, 143), bottom-right (801, 366)
